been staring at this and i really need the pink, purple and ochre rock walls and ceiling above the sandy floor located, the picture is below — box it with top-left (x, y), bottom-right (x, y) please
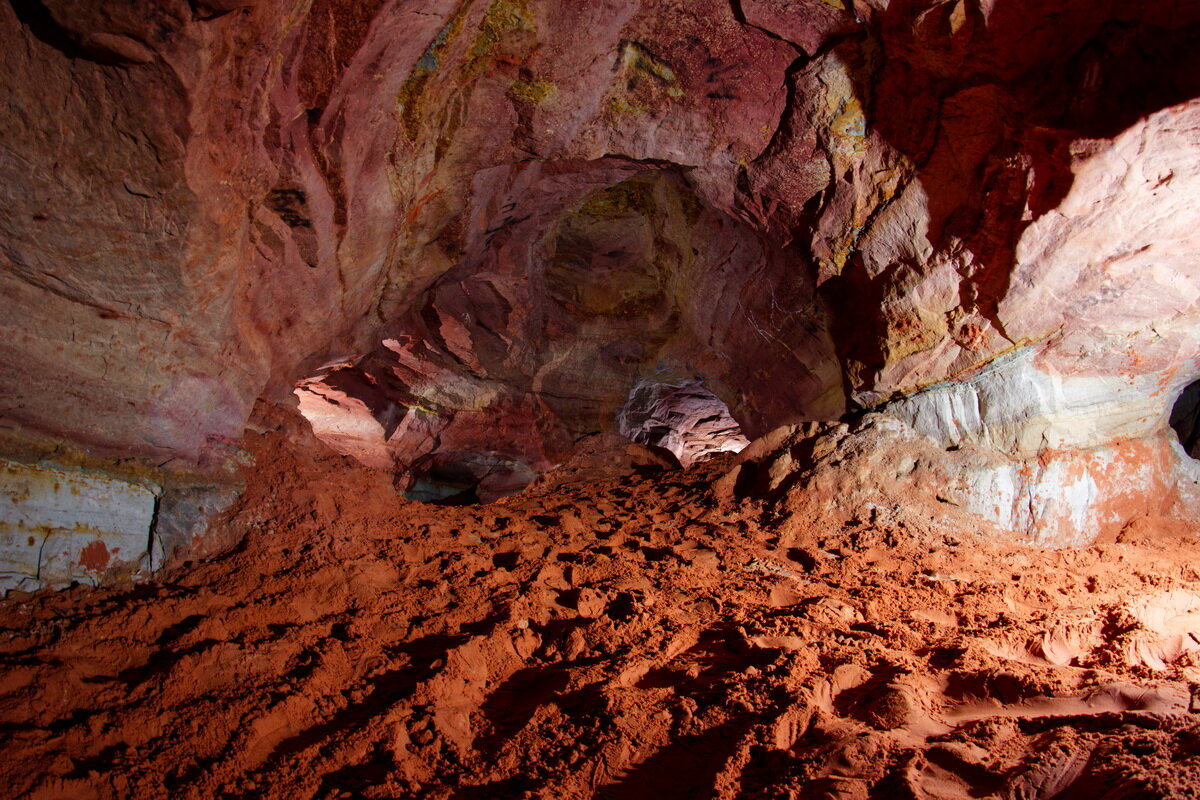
top-left (0, 0), bottom-right (1200, 561)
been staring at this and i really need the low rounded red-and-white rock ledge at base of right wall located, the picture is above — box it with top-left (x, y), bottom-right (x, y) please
top-left (719, 414), bottom-right (1200, 547)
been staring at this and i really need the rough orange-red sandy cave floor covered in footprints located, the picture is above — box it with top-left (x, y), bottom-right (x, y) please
top-left (0, 417), bottom-right (1200, 800)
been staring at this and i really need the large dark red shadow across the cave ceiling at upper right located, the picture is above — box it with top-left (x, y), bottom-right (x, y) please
top-left (859, 0), bottom-right (1200, 245)
